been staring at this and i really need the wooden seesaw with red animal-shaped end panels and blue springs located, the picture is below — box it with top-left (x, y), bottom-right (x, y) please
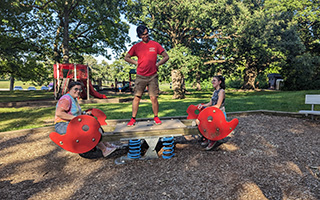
top-left (50, 105), bottom-right (239, 164)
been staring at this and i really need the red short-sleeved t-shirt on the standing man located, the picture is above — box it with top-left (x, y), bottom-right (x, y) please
top-left (128, 40), bottom-right (164, 76)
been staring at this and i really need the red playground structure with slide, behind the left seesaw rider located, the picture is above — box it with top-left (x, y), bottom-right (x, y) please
top-left (53, 63), bottom-right (107, 100)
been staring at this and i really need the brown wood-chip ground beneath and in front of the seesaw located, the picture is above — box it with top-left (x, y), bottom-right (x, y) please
top-left (0, 115), bottom-right (320, 200)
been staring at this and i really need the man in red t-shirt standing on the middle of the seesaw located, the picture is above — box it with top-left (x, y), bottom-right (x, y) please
top-left (124, 25), bottom-right (169, 126)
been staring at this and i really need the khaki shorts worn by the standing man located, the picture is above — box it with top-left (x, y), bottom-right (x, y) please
top-left (134, 74), bottom-right (159, 97)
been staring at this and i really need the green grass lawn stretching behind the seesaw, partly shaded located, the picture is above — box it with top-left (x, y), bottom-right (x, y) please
top-left (0, 89), bottom-right (320, 132)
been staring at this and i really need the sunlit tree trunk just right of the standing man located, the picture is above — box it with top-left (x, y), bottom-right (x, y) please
top-left (171, 70), bottom-right (185, 99)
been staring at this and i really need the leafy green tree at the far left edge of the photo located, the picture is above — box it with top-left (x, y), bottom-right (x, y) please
top-left (0, 1), bottom-right (50, 90)
